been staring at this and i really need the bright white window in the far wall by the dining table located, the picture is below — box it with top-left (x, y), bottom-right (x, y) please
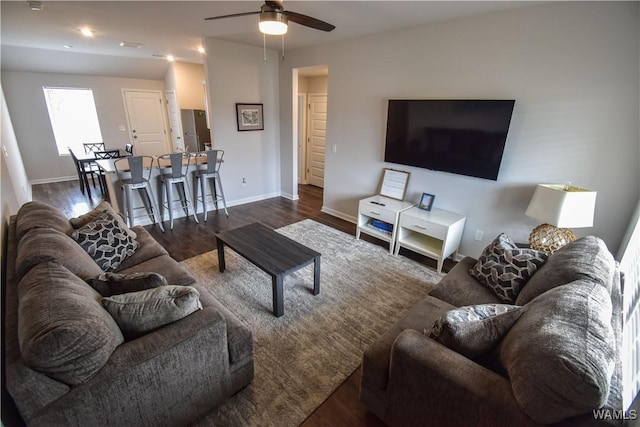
top-left (43, 87), bottom-right (102, 155)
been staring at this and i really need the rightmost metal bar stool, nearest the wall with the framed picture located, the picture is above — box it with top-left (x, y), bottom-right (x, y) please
top-left (193, 150), bottom-right (229, 222)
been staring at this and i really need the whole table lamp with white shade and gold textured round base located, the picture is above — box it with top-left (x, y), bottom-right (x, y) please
top-left (525, 183), bottom-right (596, 253)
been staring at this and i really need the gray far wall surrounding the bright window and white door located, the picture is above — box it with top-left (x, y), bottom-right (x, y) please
top-left (2, 71), bottom-right (164, 184)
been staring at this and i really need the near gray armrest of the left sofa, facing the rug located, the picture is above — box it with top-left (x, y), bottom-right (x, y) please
top-left (29, 307), bottom-right (231, 425)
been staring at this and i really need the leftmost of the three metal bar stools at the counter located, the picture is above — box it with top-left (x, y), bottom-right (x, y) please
top-left (113, 156), bottom-right (164, 233)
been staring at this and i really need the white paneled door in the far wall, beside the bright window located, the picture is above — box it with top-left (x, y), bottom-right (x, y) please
top-left (123, 89), bottom-right (173, 156)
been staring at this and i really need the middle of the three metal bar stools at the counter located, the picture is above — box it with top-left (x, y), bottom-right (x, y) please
top-left (158, 153), bottom-right (198, 230)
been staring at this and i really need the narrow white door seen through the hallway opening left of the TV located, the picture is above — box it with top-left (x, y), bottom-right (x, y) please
top-left (307, 94), bottom-right (327, 188)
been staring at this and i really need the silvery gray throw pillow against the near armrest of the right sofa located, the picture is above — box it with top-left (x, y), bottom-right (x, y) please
top-left (424, 304), bottom-right (522, 358)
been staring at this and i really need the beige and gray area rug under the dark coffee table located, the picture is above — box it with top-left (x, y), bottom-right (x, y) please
top-left (181, 220), bottom-right (442, 426)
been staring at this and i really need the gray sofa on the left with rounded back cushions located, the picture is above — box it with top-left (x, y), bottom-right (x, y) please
top-left (4, 202), bottom-right (253, 426)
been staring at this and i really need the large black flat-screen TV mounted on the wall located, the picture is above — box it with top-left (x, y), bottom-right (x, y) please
top-left (384, 99), bottom-right (515, 181)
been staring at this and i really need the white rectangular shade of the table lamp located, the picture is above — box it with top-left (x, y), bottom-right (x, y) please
top-left (526, 184), bottom-right (597, 228)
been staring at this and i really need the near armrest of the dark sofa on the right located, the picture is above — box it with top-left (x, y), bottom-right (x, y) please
top-left (385, 329), bottom-right (537, 426)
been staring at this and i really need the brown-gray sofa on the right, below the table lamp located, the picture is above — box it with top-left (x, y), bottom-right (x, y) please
top-left (360, 236), bottom-right (622, 427)
